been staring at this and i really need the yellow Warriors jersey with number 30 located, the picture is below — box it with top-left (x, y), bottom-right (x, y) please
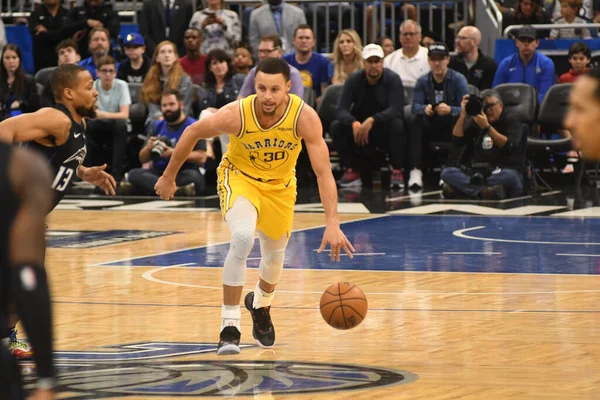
top-left (223, 94), bottom-right (304, 182)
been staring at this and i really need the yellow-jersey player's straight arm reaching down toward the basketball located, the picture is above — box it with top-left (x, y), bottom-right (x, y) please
top-left (298, 105), bottom-right (354, 261)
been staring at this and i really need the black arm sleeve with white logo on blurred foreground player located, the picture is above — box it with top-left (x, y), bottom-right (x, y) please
top-left (12, 263), bottom-right (55, 386)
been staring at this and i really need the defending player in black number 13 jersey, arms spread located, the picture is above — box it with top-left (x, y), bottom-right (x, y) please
top-left (0, 64), bottom-right (116, 359)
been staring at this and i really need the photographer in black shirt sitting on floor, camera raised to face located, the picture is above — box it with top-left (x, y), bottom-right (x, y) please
top-left (442, 89), bottom-right (525, 200)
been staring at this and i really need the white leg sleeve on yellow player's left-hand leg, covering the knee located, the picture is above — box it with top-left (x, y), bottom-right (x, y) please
top-left (223, 196), bottom-right (258, 286)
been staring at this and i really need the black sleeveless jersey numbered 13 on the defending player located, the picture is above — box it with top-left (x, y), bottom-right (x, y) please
top-left (29, 103), bottom-right (87, 209)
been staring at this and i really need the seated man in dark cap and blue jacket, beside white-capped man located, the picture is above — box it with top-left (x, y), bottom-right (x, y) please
top-left (409, 42), bottom-right (469, 188)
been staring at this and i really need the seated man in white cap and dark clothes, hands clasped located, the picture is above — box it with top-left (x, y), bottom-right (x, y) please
top-left (330, 44), bottom-right (406, 189)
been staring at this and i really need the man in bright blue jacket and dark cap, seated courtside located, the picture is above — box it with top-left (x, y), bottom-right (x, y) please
top-left (492, 25), bottom-right (556, 104)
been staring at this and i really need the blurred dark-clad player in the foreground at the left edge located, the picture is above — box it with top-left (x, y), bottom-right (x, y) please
top-left (0, 143), bottom-right (55, 400)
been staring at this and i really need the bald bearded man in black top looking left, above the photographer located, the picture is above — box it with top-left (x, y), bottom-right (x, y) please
top-left (449, 26), bottom-right (498, 90)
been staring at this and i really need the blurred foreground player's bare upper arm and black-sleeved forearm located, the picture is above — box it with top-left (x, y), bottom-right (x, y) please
top-left (10, 149), bottom-right (55, 398)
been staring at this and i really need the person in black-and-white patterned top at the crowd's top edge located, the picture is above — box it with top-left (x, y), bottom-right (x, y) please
top-left (190, 0), bottom-right (242, 57)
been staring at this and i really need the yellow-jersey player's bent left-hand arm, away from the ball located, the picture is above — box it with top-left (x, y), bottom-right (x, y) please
top-left (154, 101), bottom-right (242, 200)
